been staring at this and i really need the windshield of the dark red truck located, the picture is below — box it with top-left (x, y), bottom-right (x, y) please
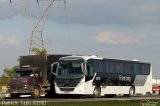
top-left (14, 70), bottom-right (33, 77)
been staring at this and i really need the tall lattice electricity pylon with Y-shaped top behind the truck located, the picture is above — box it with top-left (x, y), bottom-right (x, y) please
top-left (10, 0), bottom-right (66, 55)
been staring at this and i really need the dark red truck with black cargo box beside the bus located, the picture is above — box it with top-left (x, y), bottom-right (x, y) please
top-left (8, 55), bottom-right (67, 98)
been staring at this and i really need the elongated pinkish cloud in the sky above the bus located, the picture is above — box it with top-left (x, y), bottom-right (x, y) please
top-left (96, 32), bottom-right (139, 44)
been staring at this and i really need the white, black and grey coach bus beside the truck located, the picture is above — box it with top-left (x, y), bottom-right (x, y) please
top-left (51, 55), bottom-right (152, 97)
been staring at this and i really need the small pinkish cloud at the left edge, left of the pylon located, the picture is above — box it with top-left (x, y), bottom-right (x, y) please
top-left (0, 36), bottom-right (20, 46)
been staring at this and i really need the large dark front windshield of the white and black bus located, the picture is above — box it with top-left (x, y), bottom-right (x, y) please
top-left (56, 60), bottom-right (84, 79)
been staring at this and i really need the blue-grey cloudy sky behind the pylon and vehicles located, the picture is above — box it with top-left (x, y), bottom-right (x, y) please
top-left (0, 0), bottom-right (160, 78)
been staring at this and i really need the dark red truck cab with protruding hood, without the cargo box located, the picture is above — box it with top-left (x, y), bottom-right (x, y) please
top-left (8, 66), bottom-right (42, 98)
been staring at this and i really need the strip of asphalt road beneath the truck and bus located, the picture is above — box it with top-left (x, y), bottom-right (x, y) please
top-left (0, 95), bottom-right (160, 103)
